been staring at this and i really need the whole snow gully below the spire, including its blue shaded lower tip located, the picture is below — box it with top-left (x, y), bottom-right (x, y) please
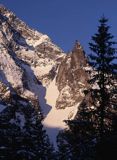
top-left (40, 77), bottom-right (78, 149)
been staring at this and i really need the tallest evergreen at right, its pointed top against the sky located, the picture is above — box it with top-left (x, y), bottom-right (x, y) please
top-left (89, 16), bottom-right (116, 138)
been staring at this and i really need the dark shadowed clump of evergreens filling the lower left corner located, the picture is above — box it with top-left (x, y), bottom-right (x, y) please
top-left (0, 95), bottom-right (54, 160)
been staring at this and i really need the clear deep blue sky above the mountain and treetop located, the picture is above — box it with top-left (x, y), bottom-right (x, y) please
top-left (0, 0), bottom-right (117, 53)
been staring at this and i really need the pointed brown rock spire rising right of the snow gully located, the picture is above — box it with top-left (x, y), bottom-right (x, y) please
top-left (56, 42), bottom-right (88, 108)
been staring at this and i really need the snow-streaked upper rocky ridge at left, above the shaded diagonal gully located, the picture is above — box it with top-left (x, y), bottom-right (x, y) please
top-left (0, 6), bottom-right (64, 84)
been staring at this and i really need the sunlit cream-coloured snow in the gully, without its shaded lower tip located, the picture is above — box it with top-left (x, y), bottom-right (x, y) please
top-left (43, 78), bottom-right (77, 129)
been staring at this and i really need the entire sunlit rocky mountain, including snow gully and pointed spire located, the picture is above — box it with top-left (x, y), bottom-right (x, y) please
top-left (0, 6), bottom-right (90, 148)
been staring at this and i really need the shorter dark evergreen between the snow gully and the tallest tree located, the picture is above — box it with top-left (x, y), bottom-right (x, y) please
top-left (57, 101), bottom-right (96, 160)
